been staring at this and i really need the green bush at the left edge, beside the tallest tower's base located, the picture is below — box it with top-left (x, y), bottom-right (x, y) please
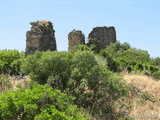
top-left (0, 50), bottom-right (23, 75)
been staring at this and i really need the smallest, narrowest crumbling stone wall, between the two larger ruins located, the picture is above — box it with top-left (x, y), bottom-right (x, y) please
top-left (68, 29), bottom-right (85, 50)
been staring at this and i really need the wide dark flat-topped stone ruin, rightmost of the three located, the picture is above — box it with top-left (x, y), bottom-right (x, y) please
top-left (88, 26), bottom-right (116, 51)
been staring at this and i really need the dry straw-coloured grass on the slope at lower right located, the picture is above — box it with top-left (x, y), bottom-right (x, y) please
top-left (124, 74), bottom-right (160, 120)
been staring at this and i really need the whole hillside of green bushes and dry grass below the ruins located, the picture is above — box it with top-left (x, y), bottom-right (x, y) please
top-left (0, 42), bottom-right (160, 120)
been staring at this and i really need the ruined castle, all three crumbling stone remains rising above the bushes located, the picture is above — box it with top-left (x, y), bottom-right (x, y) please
top-left (25, 20), bottom-right (116, 56)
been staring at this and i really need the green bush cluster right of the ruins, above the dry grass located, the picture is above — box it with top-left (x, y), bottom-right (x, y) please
top-left (100, 42), bottom-right (160, 78)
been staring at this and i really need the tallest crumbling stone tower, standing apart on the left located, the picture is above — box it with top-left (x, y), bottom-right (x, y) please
top-left (25, 20), bottom-right (57, 56)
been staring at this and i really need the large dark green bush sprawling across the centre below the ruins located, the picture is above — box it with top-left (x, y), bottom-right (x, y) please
top-left (22, 50), bottom-right (129, 119)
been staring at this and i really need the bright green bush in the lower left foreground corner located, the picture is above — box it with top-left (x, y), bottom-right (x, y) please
top-left (0, 83), bottom-right (88, 120)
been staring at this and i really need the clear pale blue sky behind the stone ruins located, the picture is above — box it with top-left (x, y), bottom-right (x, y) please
top-left (0, 0), bottom-right (160, 57)
